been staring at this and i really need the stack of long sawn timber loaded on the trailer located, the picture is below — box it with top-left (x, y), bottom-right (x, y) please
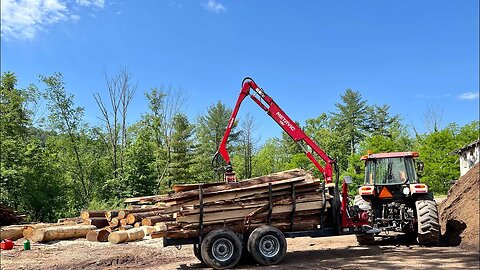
top-left (125, 169), bottom-right (330, 238)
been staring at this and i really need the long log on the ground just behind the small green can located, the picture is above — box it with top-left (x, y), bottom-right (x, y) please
top-left (31, 225), bottom-right (97, 242)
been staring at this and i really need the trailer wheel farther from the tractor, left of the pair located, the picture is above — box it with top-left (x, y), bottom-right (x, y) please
top-left (200, 229), bottom-right (242, 269)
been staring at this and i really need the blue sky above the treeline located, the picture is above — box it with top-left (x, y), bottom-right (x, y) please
top-left (1, 0), bottom-right (479, 140)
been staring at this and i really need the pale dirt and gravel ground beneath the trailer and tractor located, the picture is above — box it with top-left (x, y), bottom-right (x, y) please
top-left (1, 235), bottom-right (479, 269)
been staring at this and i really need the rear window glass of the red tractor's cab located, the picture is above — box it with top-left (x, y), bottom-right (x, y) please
top-left (365, 157), bottom-right (417, 185)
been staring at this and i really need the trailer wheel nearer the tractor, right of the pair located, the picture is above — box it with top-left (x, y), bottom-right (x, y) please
top-left (247, 226), bottom-right (287, 265)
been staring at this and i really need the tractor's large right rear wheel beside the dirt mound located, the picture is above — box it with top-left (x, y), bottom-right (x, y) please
top-left (415, 196), bottom-right (440, 245)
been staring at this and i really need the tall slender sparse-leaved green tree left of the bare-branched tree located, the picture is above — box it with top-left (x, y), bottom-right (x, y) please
top-left (40, 73), bottom-right (103, 208)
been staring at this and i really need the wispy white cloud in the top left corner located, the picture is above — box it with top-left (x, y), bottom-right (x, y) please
top-left (0, 0), bottom-right (105, 40)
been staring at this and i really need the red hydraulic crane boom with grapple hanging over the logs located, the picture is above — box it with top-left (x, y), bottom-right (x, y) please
top-left (212, 77), bottom-right (335, 184)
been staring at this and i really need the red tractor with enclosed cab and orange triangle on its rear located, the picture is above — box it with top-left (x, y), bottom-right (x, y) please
top-left (354, 152), bottom-right (440, 245)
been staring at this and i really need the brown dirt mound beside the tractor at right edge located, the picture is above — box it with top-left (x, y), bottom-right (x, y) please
top-left (439, 164), bottom-right (480, 250)
